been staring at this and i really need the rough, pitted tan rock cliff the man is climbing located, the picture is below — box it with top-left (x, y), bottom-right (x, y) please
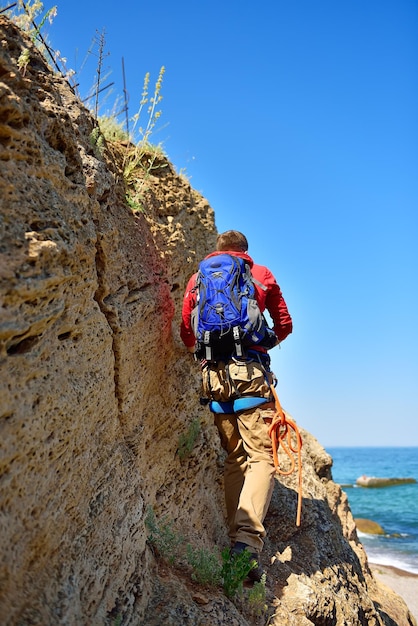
top-left (0, 16), bottom-right (415, 626)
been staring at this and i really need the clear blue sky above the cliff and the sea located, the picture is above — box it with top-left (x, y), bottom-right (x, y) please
top-left (19, 0), bottom-right (418, 447)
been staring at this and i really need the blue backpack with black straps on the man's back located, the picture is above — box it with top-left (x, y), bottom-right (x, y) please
top-left (192, 254), bottom-right (276, 361)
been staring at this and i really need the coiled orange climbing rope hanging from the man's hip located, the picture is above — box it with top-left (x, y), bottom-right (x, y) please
top-left (269, 385), bottom-right (302, 526)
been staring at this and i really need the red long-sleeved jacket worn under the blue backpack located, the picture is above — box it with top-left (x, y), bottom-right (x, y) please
top-left (180, 251), bottom-right (292, 348)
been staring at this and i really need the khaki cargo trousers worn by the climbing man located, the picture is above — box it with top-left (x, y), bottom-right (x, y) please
top-left (203, 361), bottom-right (275, 551)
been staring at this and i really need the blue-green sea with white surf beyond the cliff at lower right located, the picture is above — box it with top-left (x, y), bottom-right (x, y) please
top-left (327, 448), bottom-right (418, 574)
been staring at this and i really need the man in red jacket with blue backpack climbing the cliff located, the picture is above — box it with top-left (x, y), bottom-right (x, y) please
top-left (180, 230), bottom-right (292, 580)
